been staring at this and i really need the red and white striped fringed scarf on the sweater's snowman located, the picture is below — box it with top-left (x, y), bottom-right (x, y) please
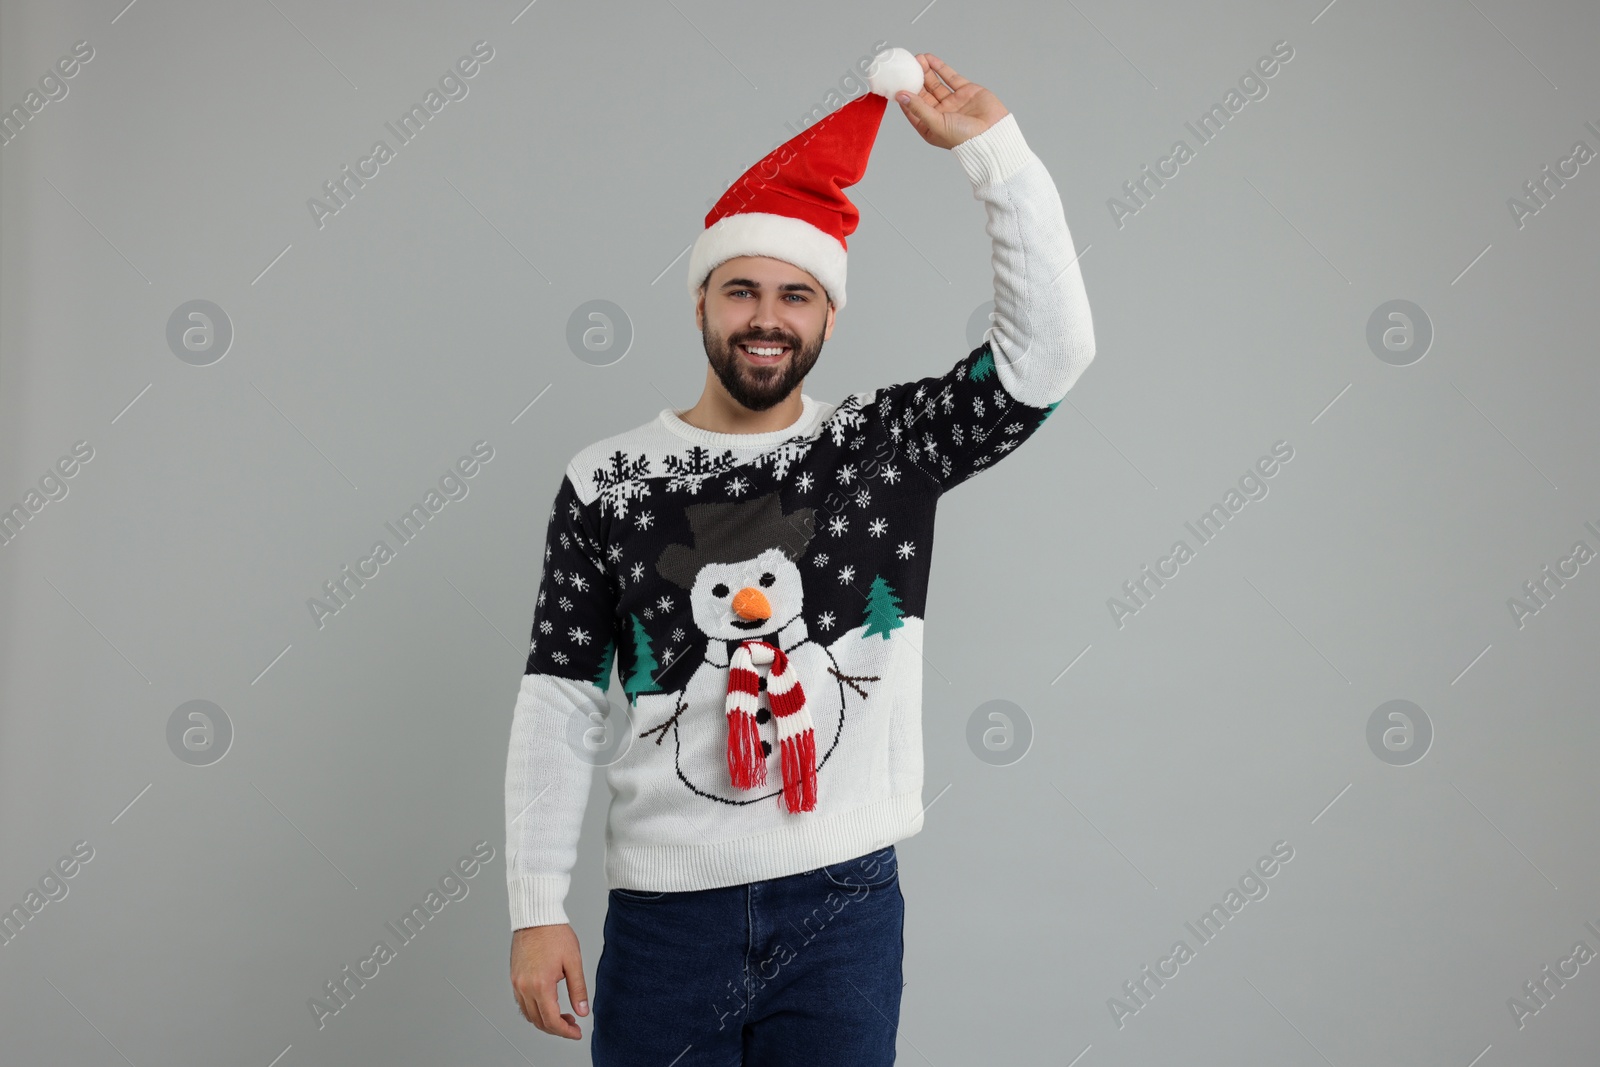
top-left (726, 640), bottom-right (816, 811)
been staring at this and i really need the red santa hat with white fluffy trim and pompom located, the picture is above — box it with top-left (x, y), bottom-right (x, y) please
top-left (690, 48), bottom-right (923, 309)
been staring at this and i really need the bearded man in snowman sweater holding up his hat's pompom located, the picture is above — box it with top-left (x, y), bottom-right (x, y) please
top-left (506, 48), bottom-right (1094, 1067)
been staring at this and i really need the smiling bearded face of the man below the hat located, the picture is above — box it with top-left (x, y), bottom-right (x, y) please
top-left (696, 256), bottom-right (834, 411)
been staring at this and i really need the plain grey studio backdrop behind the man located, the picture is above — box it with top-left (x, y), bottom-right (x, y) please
top-left (0, 0), bottom-right (1600, 1067)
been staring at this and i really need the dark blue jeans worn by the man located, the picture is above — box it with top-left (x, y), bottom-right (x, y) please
top-left (589, 845), bottom-right (906, 1067)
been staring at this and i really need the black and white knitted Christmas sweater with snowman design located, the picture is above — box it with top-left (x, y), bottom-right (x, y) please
top-left (506, 115), bottom-right (1094, 929)
